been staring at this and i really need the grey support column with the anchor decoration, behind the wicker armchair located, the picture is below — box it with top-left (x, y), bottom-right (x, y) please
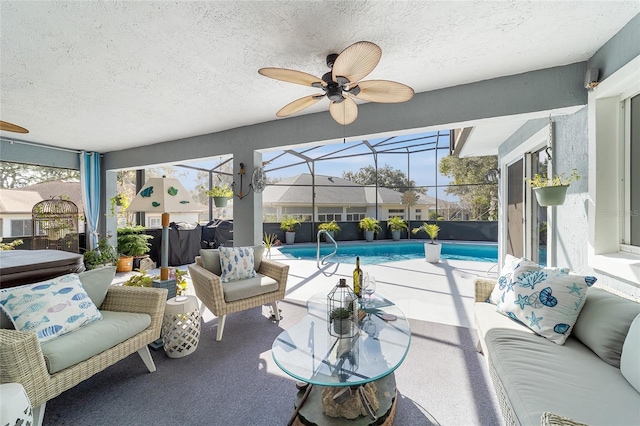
top-left (233, 149), bottom-right (262, 247)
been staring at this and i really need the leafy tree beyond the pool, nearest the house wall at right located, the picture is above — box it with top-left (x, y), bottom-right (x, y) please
top-left (438, 155), bottom-right (498, 220)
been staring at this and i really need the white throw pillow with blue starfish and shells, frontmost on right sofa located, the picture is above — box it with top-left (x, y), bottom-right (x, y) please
top-left (497, 264), bottom-right (596, 345)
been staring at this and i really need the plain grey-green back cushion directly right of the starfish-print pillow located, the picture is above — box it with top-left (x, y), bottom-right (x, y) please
top-left (572, 287), bottom-right (640, 368)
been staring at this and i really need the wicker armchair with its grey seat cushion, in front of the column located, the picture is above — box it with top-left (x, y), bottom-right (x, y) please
top-left (189, 250), bottom-right (289, 341)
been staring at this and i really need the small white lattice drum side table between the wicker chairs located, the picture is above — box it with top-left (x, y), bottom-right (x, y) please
top-left (162, 296), bottom-right (200, 358)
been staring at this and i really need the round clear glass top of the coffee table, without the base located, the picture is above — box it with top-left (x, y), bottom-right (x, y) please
top-left (272, 293), bottom-right (411, 386)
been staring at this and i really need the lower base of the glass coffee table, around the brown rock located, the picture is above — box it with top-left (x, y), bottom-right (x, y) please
top-left (293, 373), bottom-right (397, 426)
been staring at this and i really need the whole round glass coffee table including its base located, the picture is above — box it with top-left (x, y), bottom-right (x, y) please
top-left (272, 293), bottom-right (411, 425)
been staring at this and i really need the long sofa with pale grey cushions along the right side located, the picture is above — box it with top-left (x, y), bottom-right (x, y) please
top-left (474, 278), bottom-right (640, 426)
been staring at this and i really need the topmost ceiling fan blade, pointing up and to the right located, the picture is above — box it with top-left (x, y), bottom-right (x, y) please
top-left (331, 41), bottom-right (382, 83)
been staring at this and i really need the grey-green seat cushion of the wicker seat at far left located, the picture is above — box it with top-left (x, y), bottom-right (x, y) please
top-left (40, 311), bottom-right (151, 374)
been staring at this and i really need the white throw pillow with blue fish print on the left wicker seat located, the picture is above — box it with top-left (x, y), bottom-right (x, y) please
top-left (0, 274), bottom-right (102, 342)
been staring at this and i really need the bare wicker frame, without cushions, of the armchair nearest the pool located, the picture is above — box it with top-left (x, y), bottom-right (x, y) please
top-left (189, 256), bottom-right (289, 341)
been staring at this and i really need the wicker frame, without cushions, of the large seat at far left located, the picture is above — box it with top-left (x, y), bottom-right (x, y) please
top-left (0, 286), bottom-right (167, 424)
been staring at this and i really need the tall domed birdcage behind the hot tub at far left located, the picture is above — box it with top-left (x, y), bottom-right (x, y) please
top-left (31, 197), bottom-right (79, 253)
